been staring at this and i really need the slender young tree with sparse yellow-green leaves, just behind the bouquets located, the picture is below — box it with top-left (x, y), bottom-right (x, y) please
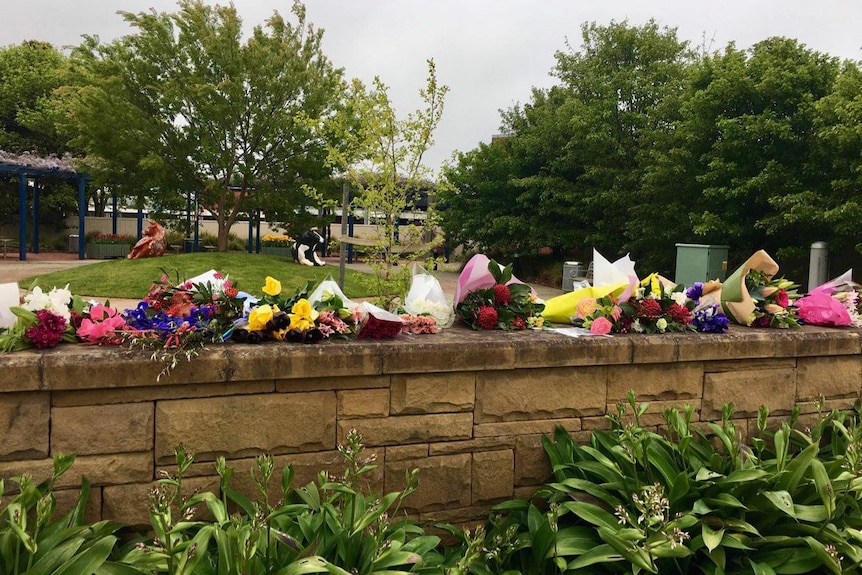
top-left (327, 60), bottom-right (449, 305)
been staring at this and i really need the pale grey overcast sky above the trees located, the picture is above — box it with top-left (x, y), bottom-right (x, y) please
top-left (0, 0), bottom-right (862, 169)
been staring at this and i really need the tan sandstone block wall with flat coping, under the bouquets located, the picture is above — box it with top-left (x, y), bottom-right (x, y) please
top-left (0, 327), bottom-right (862, 524)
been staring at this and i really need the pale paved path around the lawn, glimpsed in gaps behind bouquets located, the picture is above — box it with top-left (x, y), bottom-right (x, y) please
top-left (0, 252), bottom-right (563, 309)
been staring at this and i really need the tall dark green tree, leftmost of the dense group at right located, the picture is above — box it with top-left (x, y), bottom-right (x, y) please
top-left (445, 21), bottom-right (691, 270)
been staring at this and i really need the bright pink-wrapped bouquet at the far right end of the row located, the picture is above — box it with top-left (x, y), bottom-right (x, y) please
top-left (796, 270), bottom-right (862, 327)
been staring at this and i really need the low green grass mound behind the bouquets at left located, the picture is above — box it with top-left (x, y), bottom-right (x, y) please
top-left (18, 253), bottom-right (370, 299)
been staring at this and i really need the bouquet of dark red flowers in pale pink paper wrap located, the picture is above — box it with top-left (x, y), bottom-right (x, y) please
top-left (455, 255), bottom-right (545, 330)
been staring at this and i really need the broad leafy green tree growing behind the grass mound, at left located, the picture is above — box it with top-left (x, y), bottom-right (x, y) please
top-left (67, 0), bottom-right (341, 251)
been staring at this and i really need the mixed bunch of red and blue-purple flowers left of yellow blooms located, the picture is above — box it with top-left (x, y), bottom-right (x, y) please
top-left (122, 272), bottom-right (243, 377)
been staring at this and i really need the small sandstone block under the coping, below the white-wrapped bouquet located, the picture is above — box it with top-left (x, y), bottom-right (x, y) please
top-left (392, 372), bottom-right (476, 415)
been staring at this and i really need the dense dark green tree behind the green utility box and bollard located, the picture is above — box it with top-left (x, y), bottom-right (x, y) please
top-left (676, 38), bottom-right (838, 264)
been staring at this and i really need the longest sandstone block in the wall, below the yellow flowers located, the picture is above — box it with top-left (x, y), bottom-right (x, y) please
top-left (156, 392), bottom-right (335, 463)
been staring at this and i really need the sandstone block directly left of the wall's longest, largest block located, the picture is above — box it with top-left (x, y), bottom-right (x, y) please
top-left (51, 403), bottom-right (153, 455)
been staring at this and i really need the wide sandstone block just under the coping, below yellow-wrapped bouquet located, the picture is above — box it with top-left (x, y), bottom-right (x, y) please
top-left (476, 367), bottom-right (608, 423)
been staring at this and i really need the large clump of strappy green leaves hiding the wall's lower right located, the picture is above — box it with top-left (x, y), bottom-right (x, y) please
top-left (449, 393), bottom-right (862, 575)
